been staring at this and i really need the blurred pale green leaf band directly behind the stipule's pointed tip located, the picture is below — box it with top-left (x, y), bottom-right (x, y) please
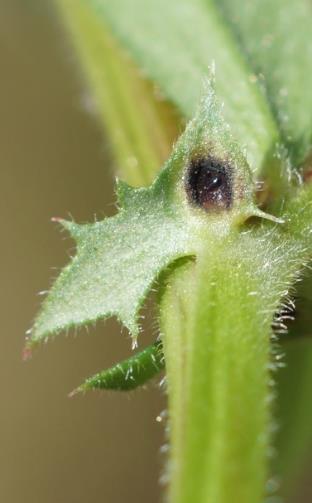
top-left (83, 0), bottom-right (279, 176)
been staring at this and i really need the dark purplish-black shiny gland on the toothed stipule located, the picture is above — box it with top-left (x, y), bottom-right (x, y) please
top-left (186, 158), bottom-right (233, 211)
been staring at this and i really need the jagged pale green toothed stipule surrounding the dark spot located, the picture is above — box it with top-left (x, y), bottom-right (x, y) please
top-left (27, 87), bottom-right (262, 348)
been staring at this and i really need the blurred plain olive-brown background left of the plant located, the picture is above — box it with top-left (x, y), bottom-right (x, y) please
top-left (0, 0), bottom-right (165, 503)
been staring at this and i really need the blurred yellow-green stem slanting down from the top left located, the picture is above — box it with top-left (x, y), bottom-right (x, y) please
top-left (54, 0), bottom-right (180, 185)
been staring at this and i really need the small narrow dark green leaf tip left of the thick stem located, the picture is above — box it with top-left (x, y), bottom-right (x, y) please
top-left (70, 341), bottom-right (165, 396)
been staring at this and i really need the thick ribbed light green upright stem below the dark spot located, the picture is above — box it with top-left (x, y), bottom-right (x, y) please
top-left (162, 238), bottom-right (270, 503)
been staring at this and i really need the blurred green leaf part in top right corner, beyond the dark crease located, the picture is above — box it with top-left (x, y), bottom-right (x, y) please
top-left (217, 0), bottom-right (312, 167)
